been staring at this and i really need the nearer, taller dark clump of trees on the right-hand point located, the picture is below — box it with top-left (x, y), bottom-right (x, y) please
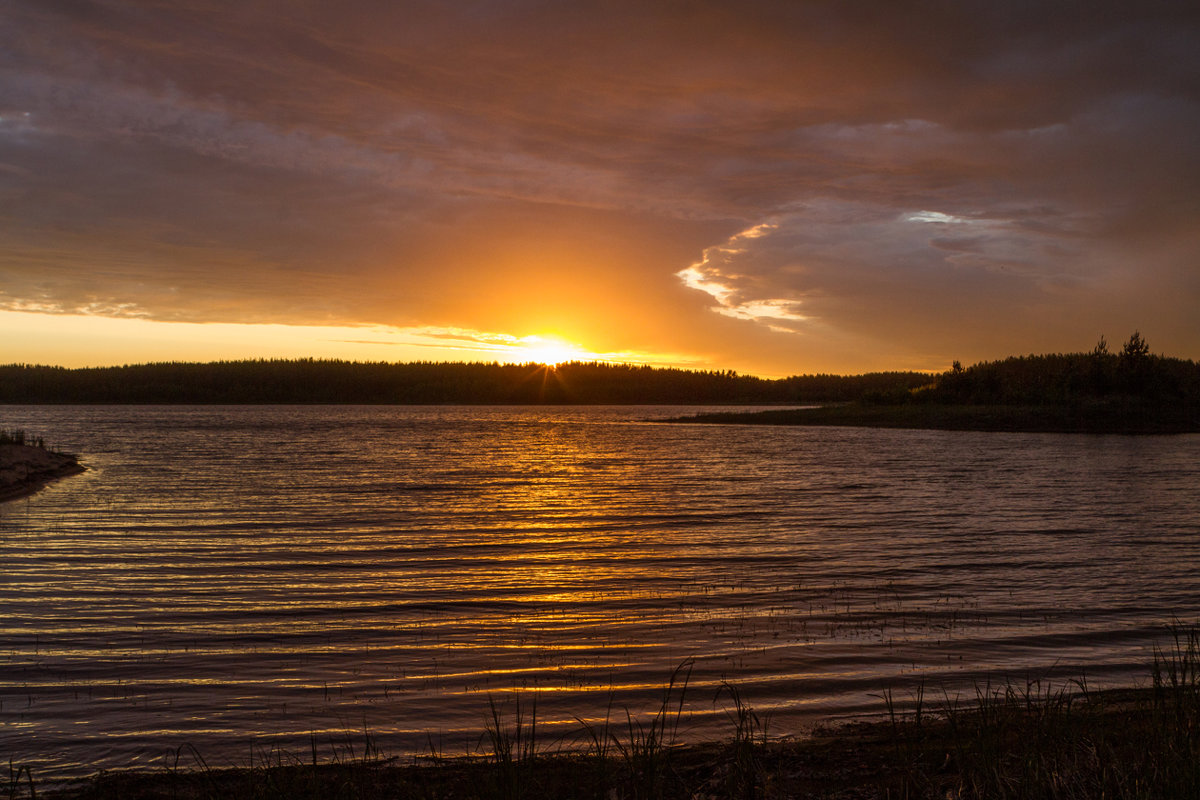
top-left (902, 331), bottom-right (1200, 407)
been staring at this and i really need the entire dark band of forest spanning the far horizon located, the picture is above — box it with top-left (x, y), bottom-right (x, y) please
top-left (0, 331), bottom-right (1200, 409)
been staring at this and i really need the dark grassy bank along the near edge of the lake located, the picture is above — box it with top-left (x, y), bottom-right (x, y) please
top-left (16, 628), bottom-right (1200, 800)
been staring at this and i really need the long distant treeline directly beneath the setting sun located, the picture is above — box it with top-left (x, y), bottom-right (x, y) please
top-left (0, 359), bottom-right (931, 404)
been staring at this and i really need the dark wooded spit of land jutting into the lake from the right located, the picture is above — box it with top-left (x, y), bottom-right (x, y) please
top-left (668, 331), bottom-right (1200, 434)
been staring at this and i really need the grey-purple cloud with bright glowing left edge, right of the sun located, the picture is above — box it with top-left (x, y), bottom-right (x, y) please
top-left (677, 191), bottom-right (1142, 351)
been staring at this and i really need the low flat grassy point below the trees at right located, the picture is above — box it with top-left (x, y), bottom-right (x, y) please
top-left (664, 403), bottom-right (1200, 435)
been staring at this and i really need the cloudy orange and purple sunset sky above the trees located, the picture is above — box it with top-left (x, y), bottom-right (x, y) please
top-left (0, 0), bottom-right (1200, 377)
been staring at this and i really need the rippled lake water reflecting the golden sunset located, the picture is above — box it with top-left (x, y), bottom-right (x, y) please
top-left (0, 407), bottom-right (1200, 777)
